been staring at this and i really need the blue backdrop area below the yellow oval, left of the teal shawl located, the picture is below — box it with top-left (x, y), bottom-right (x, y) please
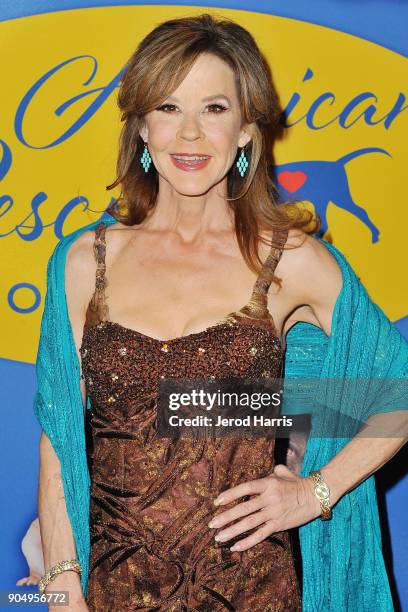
top-left (0, 359), bottom-right (47, 612)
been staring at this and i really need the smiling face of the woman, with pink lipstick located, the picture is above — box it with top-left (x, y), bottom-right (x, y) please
top-left (140, 53), bottom-right (250, 196)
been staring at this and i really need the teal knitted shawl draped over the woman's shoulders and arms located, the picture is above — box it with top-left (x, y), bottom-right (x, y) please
top-left (34, 214), bottom-right (408, 612)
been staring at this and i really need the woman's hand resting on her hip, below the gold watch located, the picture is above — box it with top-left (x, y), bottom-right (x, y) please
top-left (208, 464), bottom-right (321, 551)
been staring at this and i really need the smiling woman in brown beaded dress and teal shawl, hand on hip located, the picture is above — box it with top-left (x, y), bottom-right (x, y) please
top-left (35, 15), bottom-right (408, 611)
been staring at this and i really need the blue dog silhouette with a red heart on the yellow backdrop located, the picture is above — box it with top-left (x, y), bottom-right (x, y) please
top-left (273, 147), bottom-right (392, 243)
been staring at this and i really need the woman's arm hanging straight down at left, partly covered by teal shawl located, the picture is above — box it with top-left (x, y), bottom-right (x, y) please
top-left (38, 232), bottom-right (96, 612)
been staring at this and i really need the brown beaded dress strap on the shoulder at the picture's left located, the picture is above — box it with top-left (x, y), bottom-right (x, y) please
top-left (85, 221), bottom-right (109, 327)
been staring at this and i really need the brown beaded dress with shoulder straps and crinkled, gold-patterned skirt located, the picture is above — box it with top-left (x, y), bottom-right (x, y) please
top-left (80, 222), bottom-right (301, 612)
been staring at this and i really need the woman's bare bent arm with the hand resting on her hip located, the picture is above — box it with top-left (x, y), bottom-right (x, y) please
top-left (209, 237), bottom-right (408, 550)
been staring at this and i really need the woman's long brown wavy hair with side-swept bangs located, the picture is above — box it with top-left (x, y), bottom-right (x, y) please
top-left (107, 14), bottom-right (319, 282)
